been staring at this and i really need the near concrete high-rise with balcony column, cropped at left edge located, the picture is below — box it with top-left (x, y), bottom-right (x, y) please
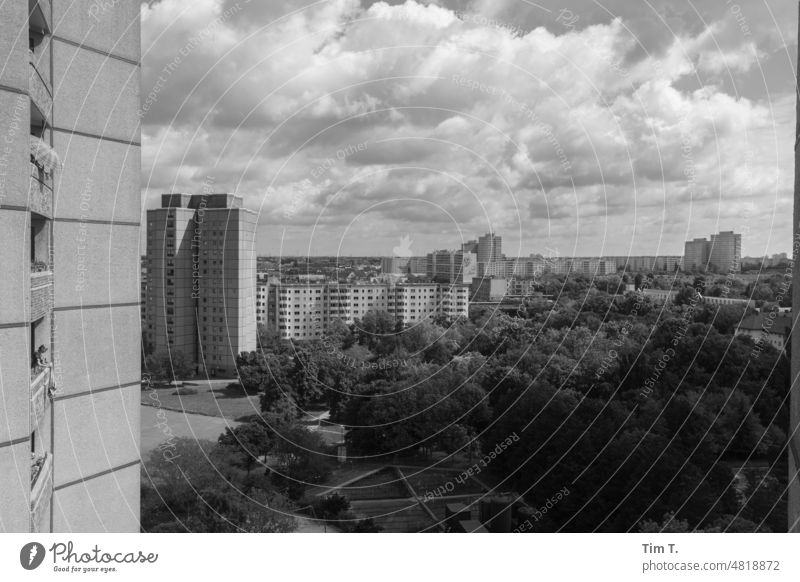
top-left (0, 0), bottom-right (141, 532)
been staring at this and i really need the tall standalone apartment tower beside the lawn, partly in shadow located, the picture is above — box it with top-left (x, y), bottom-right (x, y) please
top-left (145, 194), bottom-right (256, 376)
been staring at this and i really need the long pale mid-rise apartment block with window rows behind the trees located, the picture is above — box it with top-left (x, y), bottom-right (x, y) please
top-left (267, 283), bottom-right (469, 340)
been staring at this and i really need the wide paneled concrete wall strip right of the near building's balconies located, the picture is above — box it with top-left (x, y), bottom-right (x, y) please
top-left (52, 1), bottom-right (141, 531)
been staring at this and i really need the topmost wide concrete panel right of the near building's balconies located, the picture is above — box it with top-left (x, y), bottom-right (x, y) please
top-left (53, 0), bottom-right (140, 62)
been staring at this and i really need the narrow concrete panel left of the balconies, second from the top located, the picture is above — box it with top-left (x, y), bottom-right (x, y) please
top-left (0, 91), bottom-right (31, 206)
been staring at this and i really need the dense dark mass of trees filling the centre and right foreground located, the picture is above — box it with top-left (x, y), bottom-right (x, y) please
top-left (205, 274), bottom-right (789, 531)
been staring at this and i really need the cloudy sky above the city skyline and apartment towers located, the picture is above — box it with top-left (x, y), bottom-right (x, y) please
top-left (141, 0), bottom-right (798, 257)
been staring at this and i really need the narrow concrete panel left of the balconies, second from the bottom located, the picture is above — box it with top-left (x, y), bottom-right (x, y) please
top-left (0, 327), bottom-right (31, 442)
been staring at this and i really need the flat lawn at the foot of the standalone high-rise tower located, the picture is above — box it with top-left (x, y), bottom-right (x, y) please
top-left (142, 380), bottom-right (260, 420)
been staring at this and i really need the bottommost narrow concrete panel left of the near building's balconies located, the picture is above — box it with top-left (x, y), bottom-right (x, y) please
top-left (0, 442), bottom-right (31, 533)
